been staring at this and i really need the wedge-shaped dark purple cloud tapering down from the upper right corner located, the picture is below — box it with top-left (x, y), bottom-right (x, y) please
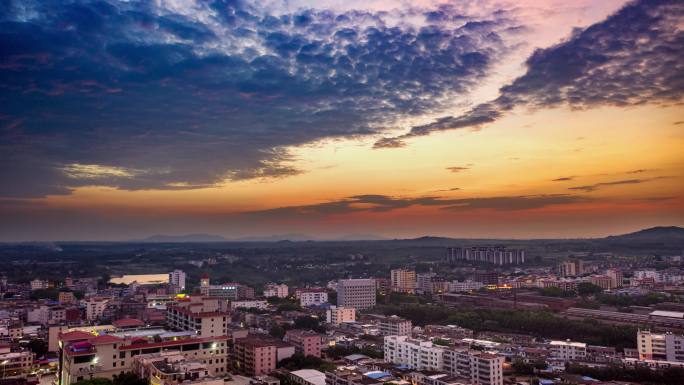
top-left (376, 0), bottom-right (684, 146)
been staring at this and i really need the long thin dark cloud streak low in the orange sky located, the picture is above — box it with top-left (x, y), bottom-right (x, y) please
top-left (242, 190), bottom-right (590, 218)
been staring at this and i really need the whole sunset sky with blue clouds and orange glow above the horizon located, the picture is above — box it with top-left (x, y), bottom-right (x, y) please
top-left (0, 0), bottom-right (684, 241)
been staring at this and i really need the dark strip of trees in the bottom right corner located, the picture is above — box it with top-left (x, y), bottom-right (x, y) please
top-left (566, 364), bottom-right (684, 385)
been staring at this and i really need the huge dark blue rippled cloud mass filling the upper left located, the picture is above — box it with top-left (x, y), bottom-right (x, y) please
top-left (0, 0), bottom-right (516, 197)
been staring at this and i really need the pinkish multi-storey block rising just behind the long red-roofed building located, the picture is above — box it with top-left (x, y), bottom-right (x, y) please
top-left (166, 297), bottom-right (230, 337)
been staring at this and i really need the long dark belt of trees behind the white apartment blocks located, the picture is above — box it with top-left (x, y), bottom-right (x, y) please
top-left (378, 305), bottom-right (637, 349)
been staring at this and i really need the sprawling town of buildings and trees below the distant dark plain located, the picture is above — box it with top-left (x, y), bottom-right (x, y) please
top-left (0, 238), bottom-right (684, 385)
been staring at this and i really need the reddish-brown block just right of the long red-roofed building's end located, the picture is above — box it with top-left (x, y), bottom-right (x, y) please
top-left (233, 336), bottom-right (277, 376)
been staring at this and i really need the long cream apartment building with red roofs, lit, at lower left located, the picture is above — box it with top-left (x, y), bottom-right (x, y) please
top-left (57, 329), bottom-right (228, 385)
